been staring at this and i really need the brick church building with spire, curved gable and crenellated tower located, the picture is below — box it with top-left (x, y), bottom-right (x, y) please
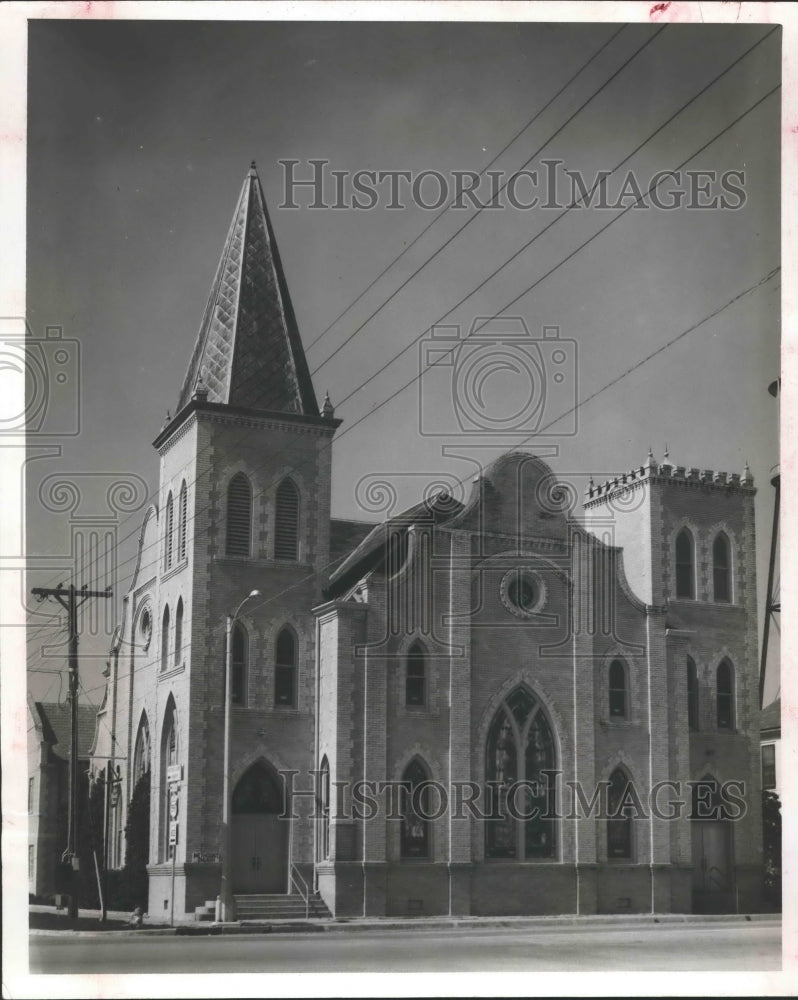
top-left (94, 164), bottom-right (762, 919)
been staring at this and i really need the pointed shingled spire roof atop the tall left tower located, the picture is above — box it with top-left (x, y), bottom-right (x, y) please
top-left (178, 161), bottom-right (319, 417)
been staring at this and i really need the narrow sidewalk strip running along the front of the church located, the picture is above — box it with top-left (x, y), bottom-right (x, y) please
top-left (29, 905), bottom-right (781, 937)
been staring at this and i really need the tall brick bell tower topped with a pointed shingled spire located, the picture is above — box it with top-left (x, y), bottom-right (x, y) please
top-left (150, 163), bottom-right (340, 912)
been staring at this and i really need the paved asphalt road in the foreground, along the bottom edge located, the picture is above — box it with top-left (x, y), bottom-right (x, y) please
top-left (30, 921), bottom-right (781, 974)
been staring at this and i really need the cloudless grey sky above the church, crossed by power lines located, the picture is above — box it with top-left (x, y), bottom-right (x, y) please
top-left (12, 11), bottom-right (781, 702)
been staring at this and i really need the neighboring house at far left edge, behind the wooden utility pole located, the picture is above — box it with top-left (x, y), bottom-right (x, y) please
top-left (28, 697), bottom-right (97, 897)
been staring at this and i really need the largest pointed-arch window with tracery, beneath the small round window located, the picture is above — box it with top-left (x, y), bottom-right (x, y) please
top-left (485, 687), bottom-right (556, 861)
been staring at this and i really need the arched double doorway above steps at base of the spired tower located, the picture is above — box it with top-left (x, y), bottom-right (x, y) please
top-left (231, 761), bottom-right (290, 894)
